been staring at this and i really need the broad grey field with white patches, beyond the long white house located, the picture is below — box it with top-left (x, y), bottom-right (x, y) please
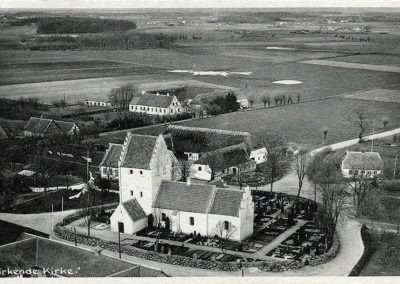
top-left (35, 47), bottom-right (398, 103)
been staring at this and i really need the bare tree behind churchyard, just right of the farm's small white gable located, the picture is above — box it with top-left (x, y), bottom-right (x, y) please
top-left (260, 132), bottom-right (289, 193)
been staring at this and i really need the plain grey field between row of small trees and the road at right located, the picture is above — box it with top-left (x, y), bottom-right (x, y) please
top-left (176, 98), bottom-right (400, 145)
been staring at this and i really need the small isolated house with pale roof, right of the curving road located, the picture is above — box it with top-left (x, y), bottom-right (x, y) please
top-left (341, 151), bottom-right (383, 178)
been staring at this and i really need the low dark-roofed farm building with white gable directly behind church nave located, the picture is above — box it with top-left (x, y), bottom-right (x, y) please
top-left (190, 143), bottom-right (257, 181)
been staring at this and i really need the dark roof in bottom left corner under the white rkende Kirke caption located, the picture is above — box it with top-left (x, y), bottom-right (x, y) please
top-left (0, 233), bottom-right (167, 278)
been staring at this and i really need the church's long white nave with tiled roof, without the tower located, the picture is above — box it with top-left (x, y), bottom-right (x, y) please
top-left (153, 181), bottom-right (254, 241)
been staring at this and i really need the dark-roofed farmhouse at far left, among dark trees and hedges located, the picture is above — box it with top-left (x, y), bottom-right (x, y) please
top-left (24, 117), bottom-right (79, 137)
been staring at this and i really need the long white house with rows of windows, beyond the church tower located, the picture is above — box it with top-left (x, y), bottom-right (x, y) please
top-left (129, 93), bottom-right (184, 116)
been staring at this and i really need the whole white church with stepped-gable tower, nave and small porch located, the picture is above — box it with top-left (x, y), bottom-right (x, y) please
top-left (111, 133), bottom-right (254, 241)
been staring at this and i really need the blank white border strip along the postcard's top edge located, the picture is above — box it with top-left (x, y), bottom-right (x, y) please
top-left (0, 0), bottom-right (400, 8)
